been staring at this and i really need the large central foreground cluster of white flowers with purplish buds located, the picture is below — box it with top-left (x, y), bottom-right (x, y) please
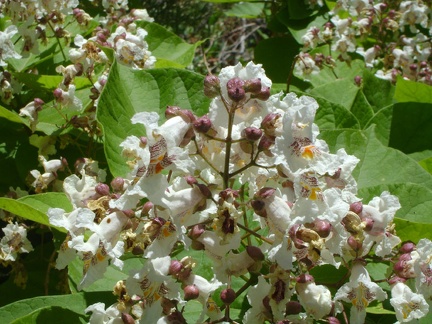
top-left (44, 63), bottom-right (432, 323)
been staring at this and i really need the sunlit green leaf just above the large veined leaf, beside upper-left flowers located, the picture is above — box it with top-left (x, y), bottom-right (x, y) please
top-left (137, 21), bottom-right (201, 68)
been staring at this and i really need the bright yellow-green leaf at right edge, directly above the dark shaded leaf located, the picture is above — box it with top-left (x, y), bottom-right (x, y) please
top-left (394, 77), bottom-right (432, 103)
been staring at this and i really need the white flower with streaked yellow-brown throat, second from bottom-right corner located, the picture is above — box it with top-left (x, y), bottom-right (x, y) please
top-left (335, 262), bottom-right (387, 324)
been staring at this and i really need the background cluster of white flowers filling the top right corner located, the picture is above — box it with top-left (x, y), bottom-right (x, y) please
top-left (296, 0), bottom-right (432, 85)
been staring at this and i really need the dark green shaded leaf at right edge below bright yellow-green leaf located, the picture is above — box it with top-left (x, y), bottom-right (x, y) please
top-left (389, 102), bottom-right (432, 154)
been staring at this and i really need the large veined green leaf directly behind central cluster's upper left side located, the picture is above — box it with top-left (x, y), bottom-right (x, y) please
top-left (97, 60), bottom-right (213, 176)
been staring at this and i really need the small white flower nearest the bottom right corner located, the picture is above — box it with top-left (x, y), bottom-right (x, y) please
top-left (390, 282), bottom-right (429, 323)
